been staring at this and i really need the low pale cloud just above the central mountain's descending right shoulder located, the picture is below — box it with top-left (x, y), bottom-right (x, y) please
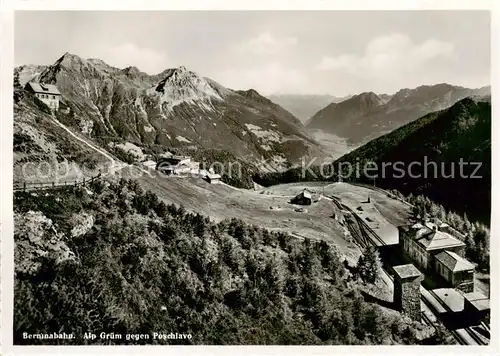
top-left (217, 62), bottom-right (306, 95)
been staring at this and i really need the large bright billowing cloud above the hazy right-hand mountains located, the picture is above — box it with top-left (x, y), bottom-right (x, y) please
top-left (316, 33), bottom-right (455, 78)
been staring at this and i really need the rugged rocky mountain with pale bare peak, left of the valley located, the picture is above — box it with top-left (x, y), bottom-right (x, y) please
top-left (14, 53), bottom-right (323, 173)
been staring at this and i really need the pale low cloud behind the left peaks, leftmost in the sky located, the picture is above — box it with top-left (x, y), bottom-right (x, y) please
top-left (92, 43), bottom-right (169, 74)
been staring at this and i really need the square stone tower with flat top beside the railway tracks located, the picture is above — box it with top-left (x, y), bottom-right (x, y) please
top-left (394, 264), bottom-right (424, 320)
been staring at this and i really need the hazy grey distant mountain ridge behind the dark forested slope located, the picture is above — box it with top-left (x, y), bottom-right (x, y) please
top-left (306, 83), bottom-right (490, 144)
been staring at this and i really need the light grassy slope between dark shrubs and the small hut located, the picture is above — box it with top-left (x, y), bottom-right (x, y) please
top-left (123, 170), bottom-right (360, 261)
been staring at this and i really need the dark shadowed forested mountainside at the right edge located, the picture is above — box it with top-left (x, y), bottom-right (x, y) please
top-left (334, 97), bottom-right (491, 224)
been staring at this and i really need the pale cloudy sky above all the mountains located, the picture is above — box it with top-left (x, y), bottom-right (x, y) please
top-left (14, 11), bottom-right (490, 96)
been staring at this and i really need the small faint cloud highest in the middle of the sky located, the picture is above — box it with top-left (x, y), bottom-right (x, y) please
top-left (237, 32), bottom-right (297, 56)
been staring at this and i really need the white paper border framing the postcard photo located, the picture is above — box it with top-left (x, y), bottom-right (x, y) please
top-left (0, 0), bottom-right (500, 356)
